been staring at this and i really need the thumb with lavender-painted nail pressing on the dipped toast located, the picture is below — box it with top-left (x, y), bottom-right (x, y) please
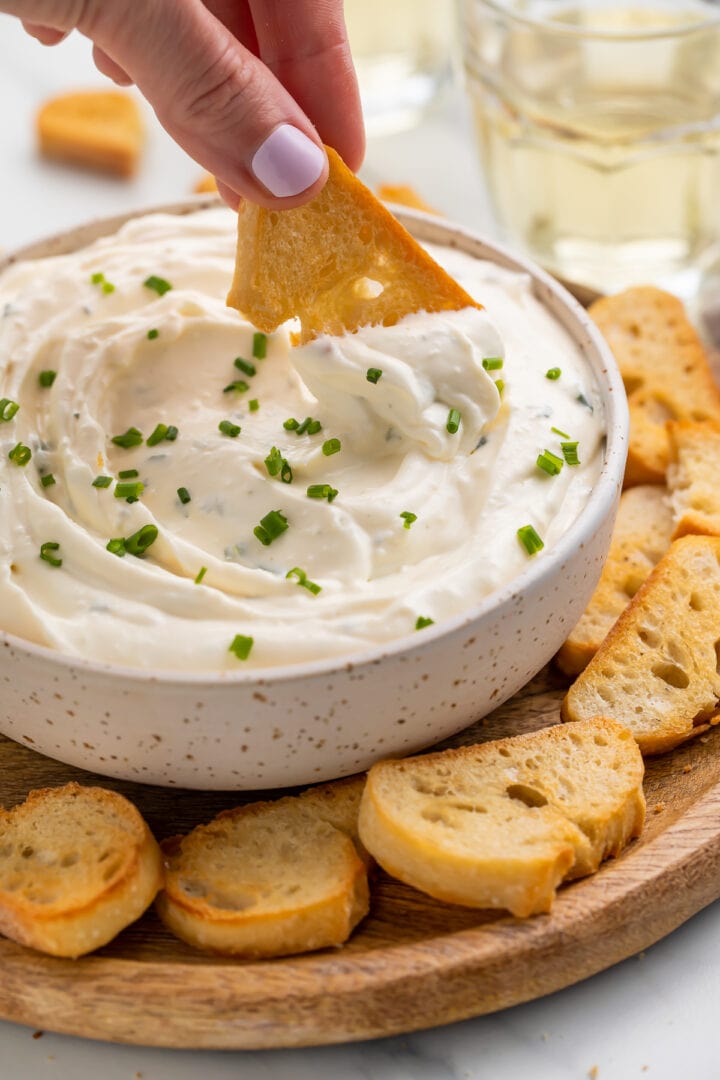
top-left (86, 0), bottom-right (327, 208)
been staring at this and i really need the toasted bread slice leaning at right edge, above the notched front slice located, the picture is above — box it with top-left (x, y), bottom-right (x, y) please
top-left (562, 536), bottom-right (720, 754)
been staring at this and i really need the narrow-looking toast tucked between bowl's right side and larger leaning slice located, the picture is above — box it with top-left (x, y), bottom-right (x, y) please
top-left (556, 484), bottom-right (673, 675)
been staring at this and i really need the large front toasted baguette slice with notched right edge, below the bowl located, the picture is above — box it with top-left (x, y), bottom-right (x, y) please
top-left (359, 719), bottom-right (644, 917)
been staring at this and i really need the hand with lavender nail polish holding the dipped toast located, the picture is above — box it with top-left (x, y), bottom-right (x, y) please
top-left (0, 0), bottom-right (365, 208)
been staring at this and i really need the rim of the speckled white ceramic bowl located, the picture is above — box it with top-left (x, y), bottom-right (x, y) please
top-left (0, 195), bottom-right (629, 687)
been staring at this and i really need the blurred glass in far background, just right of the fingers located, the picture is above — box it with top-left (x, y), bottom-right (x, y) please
top-left (344, 0), bottom-right (456, 135)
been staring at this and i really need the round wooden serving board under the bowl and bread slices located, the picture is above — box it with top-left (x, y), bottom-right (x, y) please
top-left (0, 669), bottom-right (720, 1050)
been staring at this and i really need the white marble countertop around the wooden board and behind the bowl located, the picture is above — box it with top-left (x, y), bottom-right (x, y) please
top-left (0, 15), bottom-right (720, 1080)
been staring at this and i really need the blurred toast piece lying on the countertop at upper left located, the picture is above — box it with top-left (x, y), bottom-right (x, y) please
top-left (38, 90), bottom-right (144, 177)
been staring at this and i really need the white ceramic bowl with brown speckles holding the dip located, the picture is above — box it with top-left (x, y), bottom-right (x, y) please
top-left (0, 200), bottom-right (627, 789)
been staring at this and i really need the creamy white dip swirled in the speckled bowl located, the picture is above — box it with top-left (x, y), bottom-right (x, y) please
top-left (0, 208), bottom-right (603, 672)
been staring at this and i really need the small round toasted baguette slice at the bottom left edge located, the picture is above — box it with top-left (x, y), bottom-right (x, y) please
top-left (0, 784), bottom-right (162, 957)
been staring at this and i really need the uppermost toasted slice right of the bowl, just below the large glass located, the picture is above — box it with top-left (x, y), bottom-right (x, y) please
top-left (589, 286), bottom-right (720, 487)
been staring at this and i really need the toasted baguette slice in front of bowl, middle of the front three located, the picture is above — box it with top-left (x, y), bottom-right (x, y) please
top-left (157, 781), bottom-right (369, 958)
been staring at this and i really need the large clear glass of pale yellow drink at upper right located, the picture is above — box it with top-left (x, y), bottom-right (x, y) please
top-left (459, 0), bottom-right (720, 299)
